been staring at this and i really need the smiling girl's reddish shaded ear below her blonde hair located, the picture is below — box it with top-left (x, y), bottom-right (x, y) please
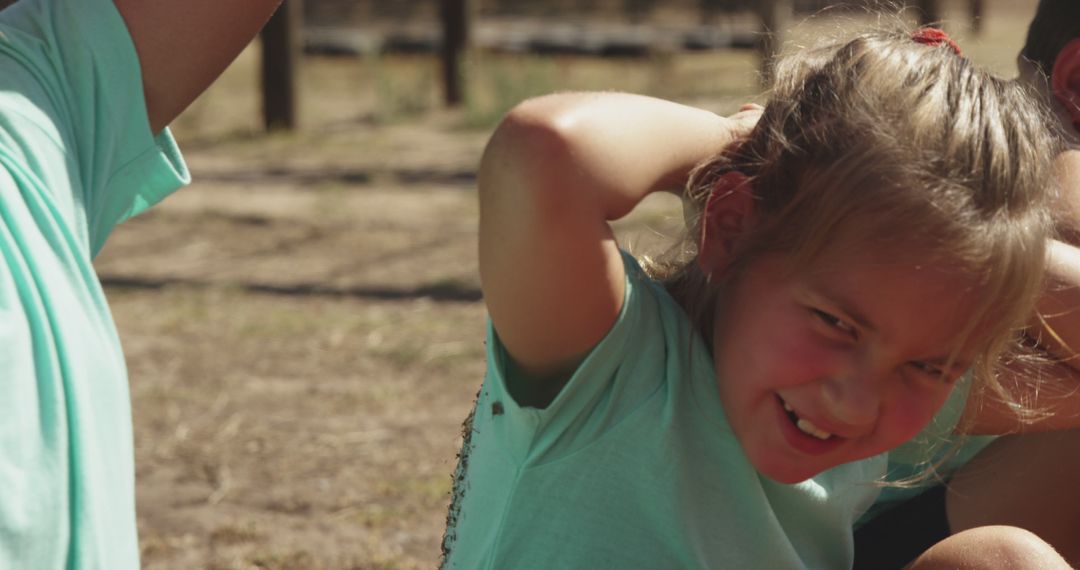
top-left (698, 171), bottom-right (754, 277)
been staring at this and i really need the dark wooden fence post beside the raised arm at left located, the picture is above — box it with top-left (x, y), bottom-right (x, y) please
top-left (260, 0), bottom-right (302, 131)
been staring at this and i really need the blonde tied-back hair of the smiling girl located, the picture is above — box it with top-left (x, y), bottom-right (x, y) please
top-left (649, 29), bottom-right (1058, 427)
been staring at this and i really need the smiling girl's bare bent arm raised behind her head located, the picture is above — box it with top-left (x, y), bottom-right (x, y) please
top-left (478, 93), bottom-right (759, 380)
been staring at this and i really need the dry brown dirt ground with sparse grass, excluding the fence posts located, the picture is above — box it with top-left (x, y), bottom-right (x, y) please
top-left (97, 1), bottom-right (1031, 570)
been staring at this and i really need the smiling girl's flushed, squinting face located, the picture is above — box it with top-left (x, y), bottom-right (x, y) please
top-left (713, 255), bottom-right (989, 483)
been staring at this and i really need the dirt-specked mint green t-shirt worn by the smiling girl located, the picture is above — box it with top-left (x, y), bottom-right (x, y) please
top-left (444, 256), bottom-right (886, 570)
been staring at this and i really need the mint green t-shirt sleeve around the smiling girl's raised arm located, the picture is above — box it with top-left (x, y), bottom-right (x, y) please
top-left (476, 253), bottom-right (667, 461)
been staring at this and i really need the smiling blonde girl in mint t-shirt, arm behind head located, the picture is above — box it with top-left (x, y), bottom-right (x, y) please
top-left (444, 25), bottom-right (1055, 569)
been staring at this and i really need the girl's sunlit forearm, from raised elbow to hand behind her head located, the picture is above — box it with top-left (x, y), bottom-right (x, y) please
top-left (482, 93), bottom-right (737, 220)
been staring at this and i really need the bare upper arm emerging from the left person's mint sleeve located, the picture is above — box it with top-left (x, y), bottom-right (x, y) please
top-left (114, 0), bottom-right (282, 133)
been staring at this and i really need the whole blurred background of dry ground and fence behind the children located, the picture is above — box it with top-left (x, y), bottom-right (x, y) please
top-left (90, 0), bottom-right (1035, 570)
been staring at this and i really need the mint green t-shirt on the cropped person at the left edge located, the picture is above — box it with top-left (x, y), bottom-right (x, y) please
top-left (0, 0), bottom-right (188, 570)
